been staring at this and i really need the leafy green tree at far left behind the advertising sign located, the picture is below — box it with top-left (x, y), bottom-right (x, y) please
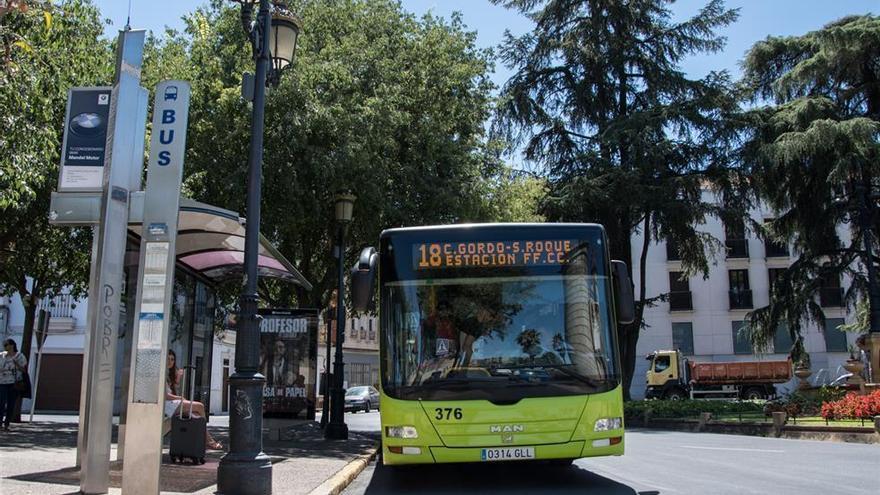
top-left (0, 0), bottom-right (113, 418)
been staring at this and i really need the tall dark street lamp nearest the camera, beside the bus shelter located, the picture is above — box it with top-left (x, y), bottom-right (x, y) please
top-left (217, 0), bottom-right (300, 495)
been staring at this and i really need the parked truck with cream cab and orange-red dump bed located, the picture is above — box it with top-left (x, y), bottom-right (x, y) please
top-left (645, 351), bottom-right (791, 400)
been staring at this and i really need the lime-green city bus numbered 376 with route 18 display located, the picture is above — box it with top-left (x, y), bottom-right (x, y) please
top-left (352, 224), bottom-right (633, 465)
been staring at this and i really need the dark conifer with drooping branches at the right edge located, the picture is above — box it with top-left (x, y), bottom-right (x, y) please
top-left (739, 15), bottom-right (880, 359)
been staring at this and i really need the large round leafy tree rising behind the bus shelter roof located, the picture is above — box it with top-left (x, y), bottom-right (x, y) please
top-left (145, 0), bottom-right (508, 307)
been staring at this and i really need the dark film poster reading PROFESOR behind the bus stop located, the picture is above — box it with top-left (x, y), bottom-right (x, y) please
top-left (260, 309), bottom-right (318, 419)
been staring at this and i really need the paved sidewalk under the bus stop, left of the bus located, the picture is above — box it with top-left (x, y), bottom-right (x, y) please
top-left (0, 418), bottom-right (378, 495)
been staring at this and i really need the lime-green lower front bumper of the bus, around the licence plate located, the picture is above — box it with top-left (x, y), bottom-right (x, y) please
top-left (382, 438), bottom-right (624, 465)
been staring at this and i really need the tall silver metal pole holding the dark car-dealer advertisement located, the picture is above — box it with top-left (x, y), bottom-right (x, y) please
top-left (78, 30), bottom-right (148, 494)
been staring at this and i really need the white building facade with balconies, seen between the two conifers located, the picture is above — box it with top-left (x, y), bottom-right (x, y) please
top-left (630, 191), bottom-right (855, 398)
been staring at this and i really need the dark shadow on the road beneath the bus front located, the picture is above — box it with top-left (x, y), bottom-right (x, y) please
top-left (354, 460), bottom-right (658, 495)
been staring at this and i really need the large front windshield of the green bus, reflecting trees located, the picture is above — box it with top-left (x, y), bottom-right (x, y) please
top-left (381, 225), bottom-right (619, 404)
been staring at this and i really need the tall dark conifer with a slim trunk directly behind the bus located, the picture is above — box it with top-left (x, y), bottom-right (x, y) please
top-left (493, 0), bottom-right (737, 398)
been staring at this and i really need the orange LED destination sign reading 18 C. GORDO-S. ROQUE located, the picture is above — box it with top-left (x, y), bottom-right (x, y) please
top-left (413, 239), bottom-right (578, 270)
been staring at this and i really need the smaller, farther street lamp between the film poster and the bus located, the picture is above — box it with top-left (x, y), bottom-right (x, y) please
top-left (324, 193), bottom-right (356, 440)
